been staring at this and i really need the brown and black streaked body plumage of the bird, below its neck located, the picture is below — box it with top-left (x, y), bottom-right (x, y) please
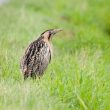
top-left (21, 38), bottom-right (51, 79)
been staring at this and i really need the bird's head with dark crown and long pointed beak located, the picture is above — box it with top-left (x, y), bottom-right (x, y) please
top-left (41, 29), bottom-right (62, 40)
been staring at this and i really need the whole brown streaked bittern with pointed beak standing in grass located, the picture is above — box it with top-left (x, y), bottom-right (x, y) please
top-left (20, 29), bottom-right (62, 80)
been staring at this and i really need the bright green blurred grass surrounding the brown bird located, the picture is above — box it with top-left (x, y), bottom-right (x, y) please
top-left (0, 0), bottom-right (110, 110)
